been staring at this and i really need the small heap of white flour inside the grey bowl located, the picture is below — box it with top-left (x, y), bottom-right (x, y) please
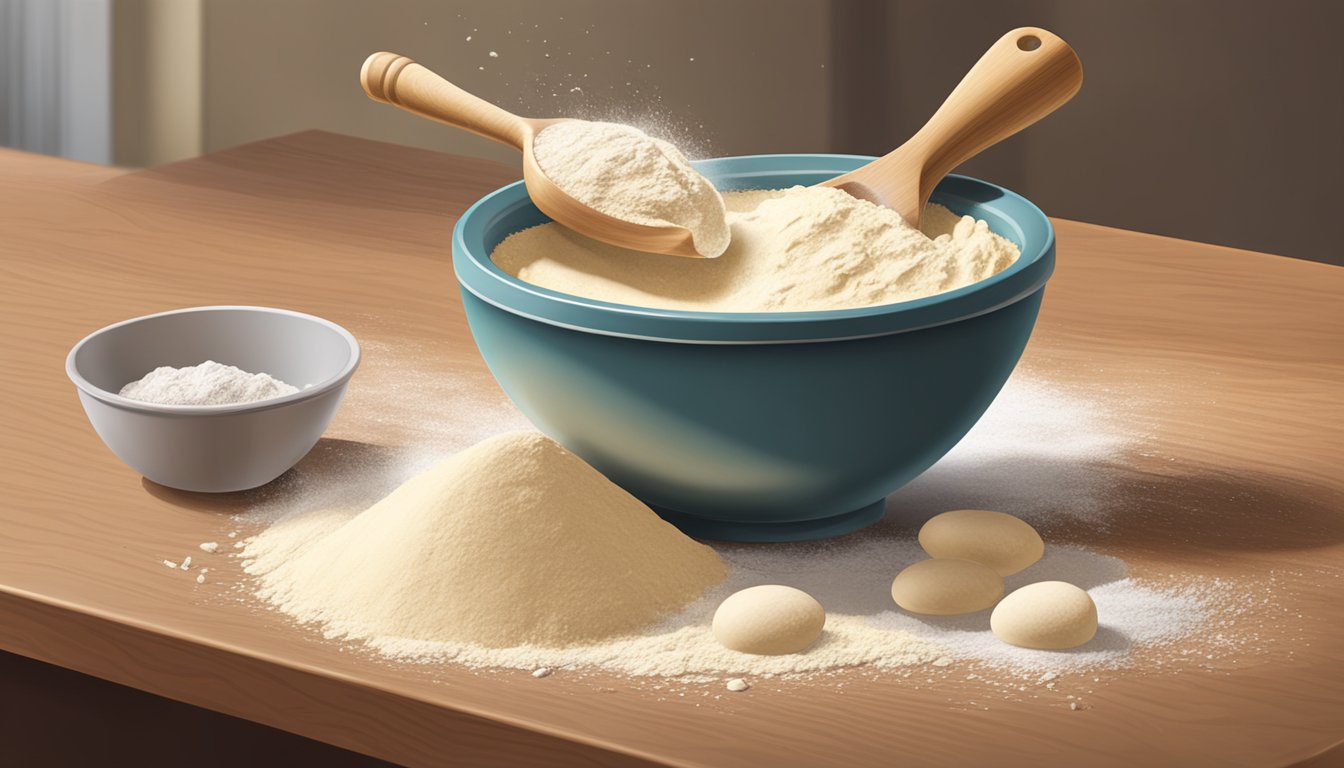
top-left (120, 360), bottom-right (298, 405)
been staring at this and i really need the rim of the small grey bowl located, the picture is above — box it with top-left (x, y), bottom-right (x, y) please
top-left (66, 304), bottom-right (360, 416)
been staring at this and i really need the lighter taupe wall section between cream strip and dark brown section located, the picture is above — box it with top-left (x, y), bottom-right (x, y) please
top-left (202, 0), bottom-right (831, 163)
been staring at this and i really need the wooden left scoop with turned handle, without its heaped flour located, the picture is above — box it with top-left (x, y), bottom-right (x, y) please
top-left (359, 52), bottom-right (703, 258)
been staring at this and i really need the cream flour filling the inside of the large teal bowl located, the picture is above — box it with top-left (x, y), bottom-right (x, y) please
top-left (491, 187), bottom-right (1019, 312)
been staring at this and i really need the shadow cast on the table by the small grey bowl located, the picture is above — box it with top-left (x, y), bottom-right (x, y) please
top-left (141, 437), bottom-right (406, 515)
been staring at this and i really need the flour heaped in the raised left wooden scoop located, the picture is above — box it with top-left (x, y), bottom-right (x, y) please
top-left (532, 120), bottom-right (730, 261)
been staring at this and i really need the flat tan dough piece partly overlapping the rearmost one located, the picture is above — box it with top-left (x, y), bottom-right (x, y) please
top-left (891, 560), bottom-right (1004, 616)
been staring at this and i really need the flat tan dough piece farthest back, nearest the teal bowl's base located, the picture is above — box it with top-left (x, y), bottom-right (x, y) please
top-left (919, 510), bottom-right (1046, 576)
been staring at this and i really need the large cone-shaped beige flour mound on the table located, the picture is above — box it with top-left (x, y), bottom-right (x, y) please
top-left (245, 432), bottom-right (727, 648)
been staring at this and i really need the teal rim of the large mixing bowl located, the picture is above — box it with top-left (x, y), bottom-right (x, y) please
top-left (452, 153), bottom-right (1055, 344)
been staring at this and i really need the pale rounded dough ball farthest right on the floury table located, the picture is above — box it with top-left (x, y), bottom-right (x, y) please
top-left (989, 581), bottom-right (1097, 651)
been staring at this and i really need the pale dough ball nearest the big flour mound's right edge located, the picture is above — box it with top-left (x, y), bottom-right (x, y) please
top-left (711, 584), bottom-right (827, 656)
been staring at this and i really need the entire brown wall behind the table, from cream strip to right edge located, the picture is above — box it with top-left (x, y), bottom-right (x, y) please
top-left (92, 0), bottom-right (1344, 264)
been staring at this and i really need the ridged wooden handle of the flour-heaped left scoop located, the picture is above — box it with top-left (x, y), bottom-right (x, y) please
top-left (359, 51), bottom-right (531, 151)
